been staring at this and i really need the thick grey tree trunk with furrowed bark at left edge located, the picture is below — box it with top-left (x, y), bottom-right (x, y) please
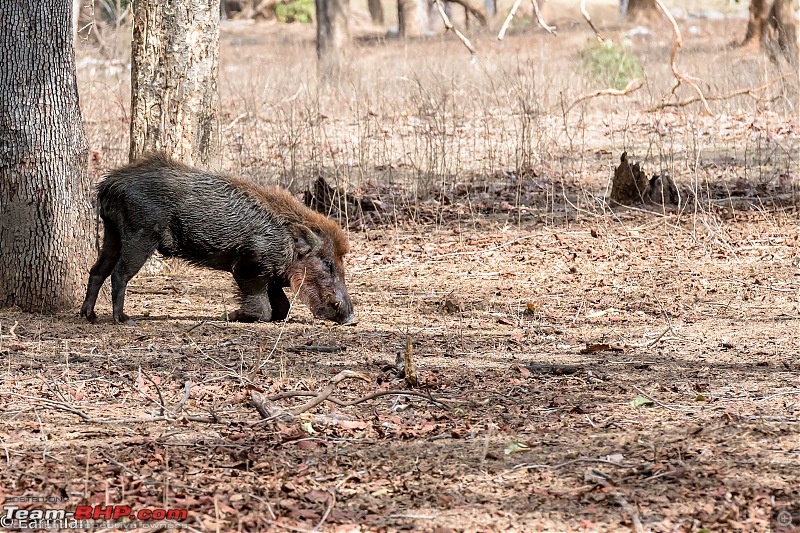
top-left (0, 0), bottom-right (94, 313)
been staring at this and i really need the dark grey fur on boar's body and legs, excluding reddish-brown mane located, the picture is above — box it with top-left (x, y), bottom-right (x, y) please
top-left (81, 155), bottom-right (353, 324)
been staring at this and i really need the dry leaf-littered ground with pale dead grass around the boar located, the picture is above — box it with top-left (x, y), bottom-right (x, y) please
top-left (0, 2), bottom-right (800, 532)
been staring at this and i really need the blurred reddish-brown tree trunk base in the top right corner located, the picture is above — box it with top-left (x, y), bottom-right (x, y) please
top-left (742, 0), bottom-right (798, 65)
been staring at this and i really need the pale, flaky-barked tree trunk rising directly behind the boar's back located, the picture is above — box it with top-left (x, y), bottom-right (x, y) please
top-left (130, 0), bottom-right (220, 165)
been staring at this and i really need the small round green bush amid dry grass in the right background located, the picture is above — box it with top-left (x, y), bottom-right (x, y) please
top-left (579, 39), bottom-right (644, 89)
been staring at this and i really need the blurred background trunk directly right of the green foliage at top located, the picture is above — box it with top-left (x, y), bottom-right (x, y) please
top-left (316, 0), bottom-right (350, 79)
